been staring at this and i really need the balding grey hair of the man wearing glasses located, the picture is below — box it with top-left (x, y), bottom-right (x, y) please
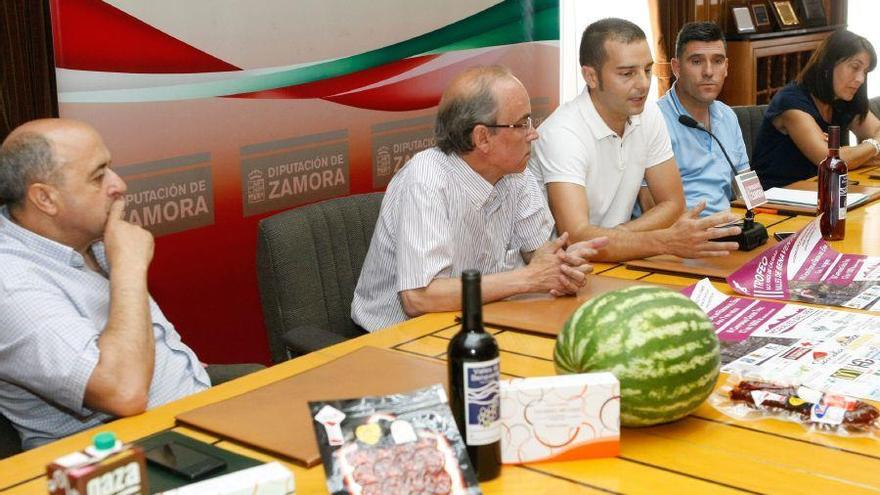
top-left (434, 65), bottom-right (513, 154)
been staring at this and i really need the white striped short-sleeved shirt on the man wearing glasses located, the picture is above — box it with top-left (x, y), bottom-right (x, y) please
top-left (351, 148), bottom-right (553, 332)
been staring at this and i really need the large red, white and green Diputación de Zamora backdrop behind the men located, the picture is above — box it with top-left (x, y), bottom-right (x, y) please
top-left (50, 0), bottom-right (560, 363)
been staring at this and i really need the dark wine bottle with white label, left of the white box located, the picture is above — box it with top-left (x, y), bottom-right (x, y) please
top-left (447, 270), bottom-right (501, 481)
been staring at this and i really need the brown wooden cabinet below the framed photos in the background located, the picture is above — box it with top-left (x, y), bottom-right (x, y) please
top-left (719, 27), bottom-right (833, 106)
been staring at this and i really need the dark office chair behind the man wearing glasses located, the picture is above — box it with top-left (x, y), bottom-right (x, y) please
top-left (257, 193), bottom-right (383, 363)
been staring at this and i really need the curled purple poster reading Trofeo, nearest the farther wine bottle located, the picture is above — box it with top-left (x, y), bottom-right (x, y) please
top-left (727, 218), bottom-right (880, 312)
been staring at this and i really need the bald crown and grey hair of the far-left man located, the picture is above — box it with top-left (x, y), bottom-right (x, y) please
top-left (0, 119), bottom-right (101, 207)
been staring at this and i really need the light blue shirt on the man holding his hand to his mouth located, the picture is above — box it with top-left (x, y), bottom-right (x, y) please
top-left (0, 206), bottom-right (211, 449)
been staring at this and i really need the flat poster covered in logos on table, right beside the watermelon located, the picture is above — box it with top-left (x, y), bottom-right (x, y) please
top-left (682, 279), bottom-right (880, 400)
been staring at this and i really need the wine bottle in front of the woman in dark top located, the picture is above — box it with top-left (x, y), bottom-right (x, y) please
top-left (816, 125), bottom-right (848, 241)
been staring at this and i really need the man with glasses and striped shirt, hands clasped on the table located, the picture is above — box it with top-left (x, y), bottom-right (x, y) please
top-left (351, 66), bottom-right (606, 332)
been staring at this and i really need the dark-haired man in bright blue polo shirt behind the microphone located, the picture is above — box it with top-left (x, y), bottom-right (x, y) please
top-left (657, 22), bottom-right (749, 216)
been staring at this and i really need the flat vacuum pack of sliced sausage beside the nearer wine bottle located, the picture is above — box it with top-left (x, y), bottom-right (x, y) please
top-left (309, 384), bottom-right (482, 495)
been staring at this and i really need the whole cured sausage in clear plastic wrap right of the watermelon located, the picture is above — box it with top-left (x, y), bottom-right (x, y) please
top-left (709, 374), bottom-right (880, 438)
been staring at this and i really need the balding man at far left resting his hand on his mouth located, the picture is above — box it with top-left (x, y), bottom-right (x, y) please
top-left (0, 119), bottom-right (210, 449)
